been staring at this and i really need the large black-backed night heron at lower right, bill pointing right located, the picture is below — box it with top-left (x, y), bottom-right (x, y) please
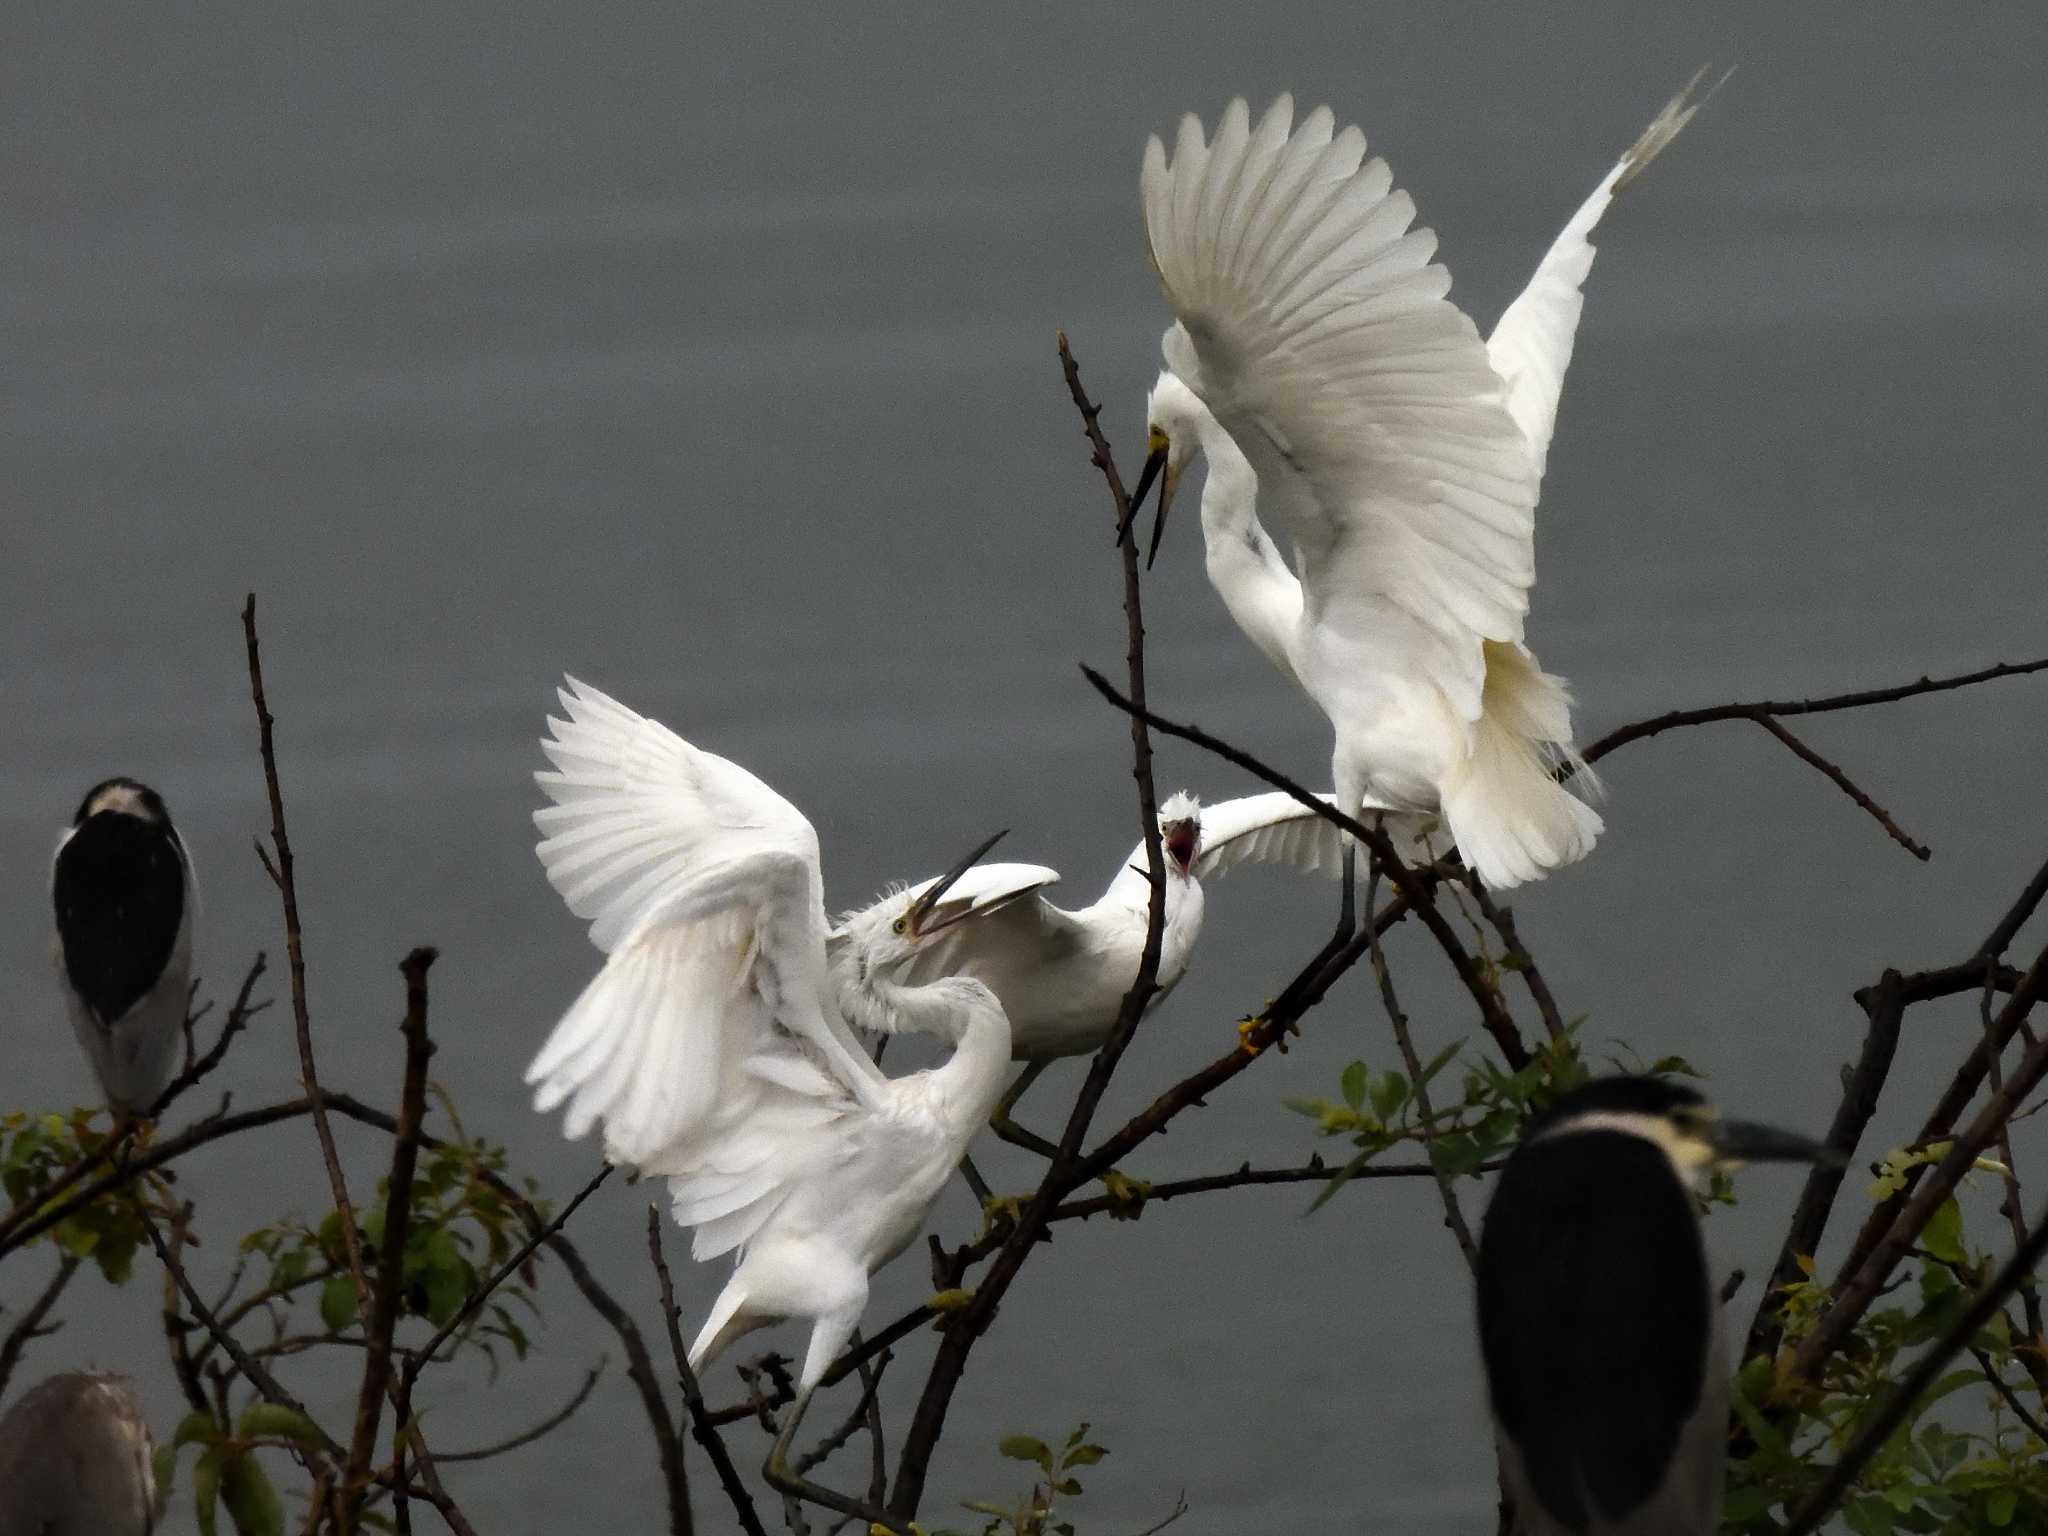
top-left (1479, 1077), bottom-right (1835, 1536)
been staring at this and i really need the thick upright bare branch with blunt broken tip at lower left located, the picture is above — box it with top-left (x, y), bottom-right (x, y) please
top-left (340, 948), bottom-right (436, 1528)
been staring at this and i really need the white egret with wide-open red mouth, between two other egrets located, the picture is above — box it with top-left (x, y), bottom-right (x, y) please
top-left (829, 791), bottom-right (1425, 1155)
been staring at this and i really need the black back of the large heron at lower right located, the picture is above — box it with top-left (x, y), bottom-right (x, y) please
top-left (1479, 1130), bottom-right (1712, 1532)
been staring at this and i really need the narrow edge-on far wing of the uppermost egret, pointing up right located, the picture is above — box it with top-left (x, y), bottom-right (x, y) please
top-left (1487, 70), bottom-right (1706, 475)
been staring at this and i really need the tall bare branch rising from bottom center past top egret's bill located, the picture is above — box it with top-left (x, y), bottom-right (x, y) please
top-left (889, 332), bottom-right (1165, 1522)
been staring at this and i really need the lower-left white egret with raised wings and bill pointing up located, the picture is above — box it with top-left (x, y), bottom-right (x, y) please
top-left (526, 678), bottom-right (1010, 1395)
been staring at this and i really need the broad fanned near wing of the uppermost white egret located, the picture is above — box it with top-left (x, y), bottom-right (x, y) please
top-left (1143, 96), bottom-right (1538, 721)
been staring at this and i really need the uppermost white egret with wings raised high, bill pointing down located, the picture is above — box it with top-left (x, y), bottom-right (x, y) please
top-left (1133, 86), bottom-right (1696, 888)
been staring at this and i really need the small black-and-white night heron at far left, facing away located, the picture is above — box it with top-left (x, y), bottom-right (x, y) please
top-left (49, 778), bottom-right (197, 1118)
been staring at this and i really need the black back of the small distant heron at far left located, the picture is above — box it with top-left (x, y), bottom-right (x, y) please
top-left (53, 811), bottom-right (186, 1024)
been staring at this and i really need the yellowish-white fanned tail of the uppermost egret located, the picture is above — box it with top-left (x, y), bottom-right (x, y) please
top-left (1442, 641), bottom-right (1602, 889)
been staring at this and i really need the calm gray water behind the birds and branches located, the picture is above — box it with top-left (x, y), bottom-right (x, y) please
top-left (0, 0), bottom-right (2048, 1536)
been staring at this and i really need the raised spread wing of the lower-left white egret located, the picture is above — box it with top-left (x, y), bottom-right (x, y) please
top-left (526, 678), bottom-right (881, 1167)
